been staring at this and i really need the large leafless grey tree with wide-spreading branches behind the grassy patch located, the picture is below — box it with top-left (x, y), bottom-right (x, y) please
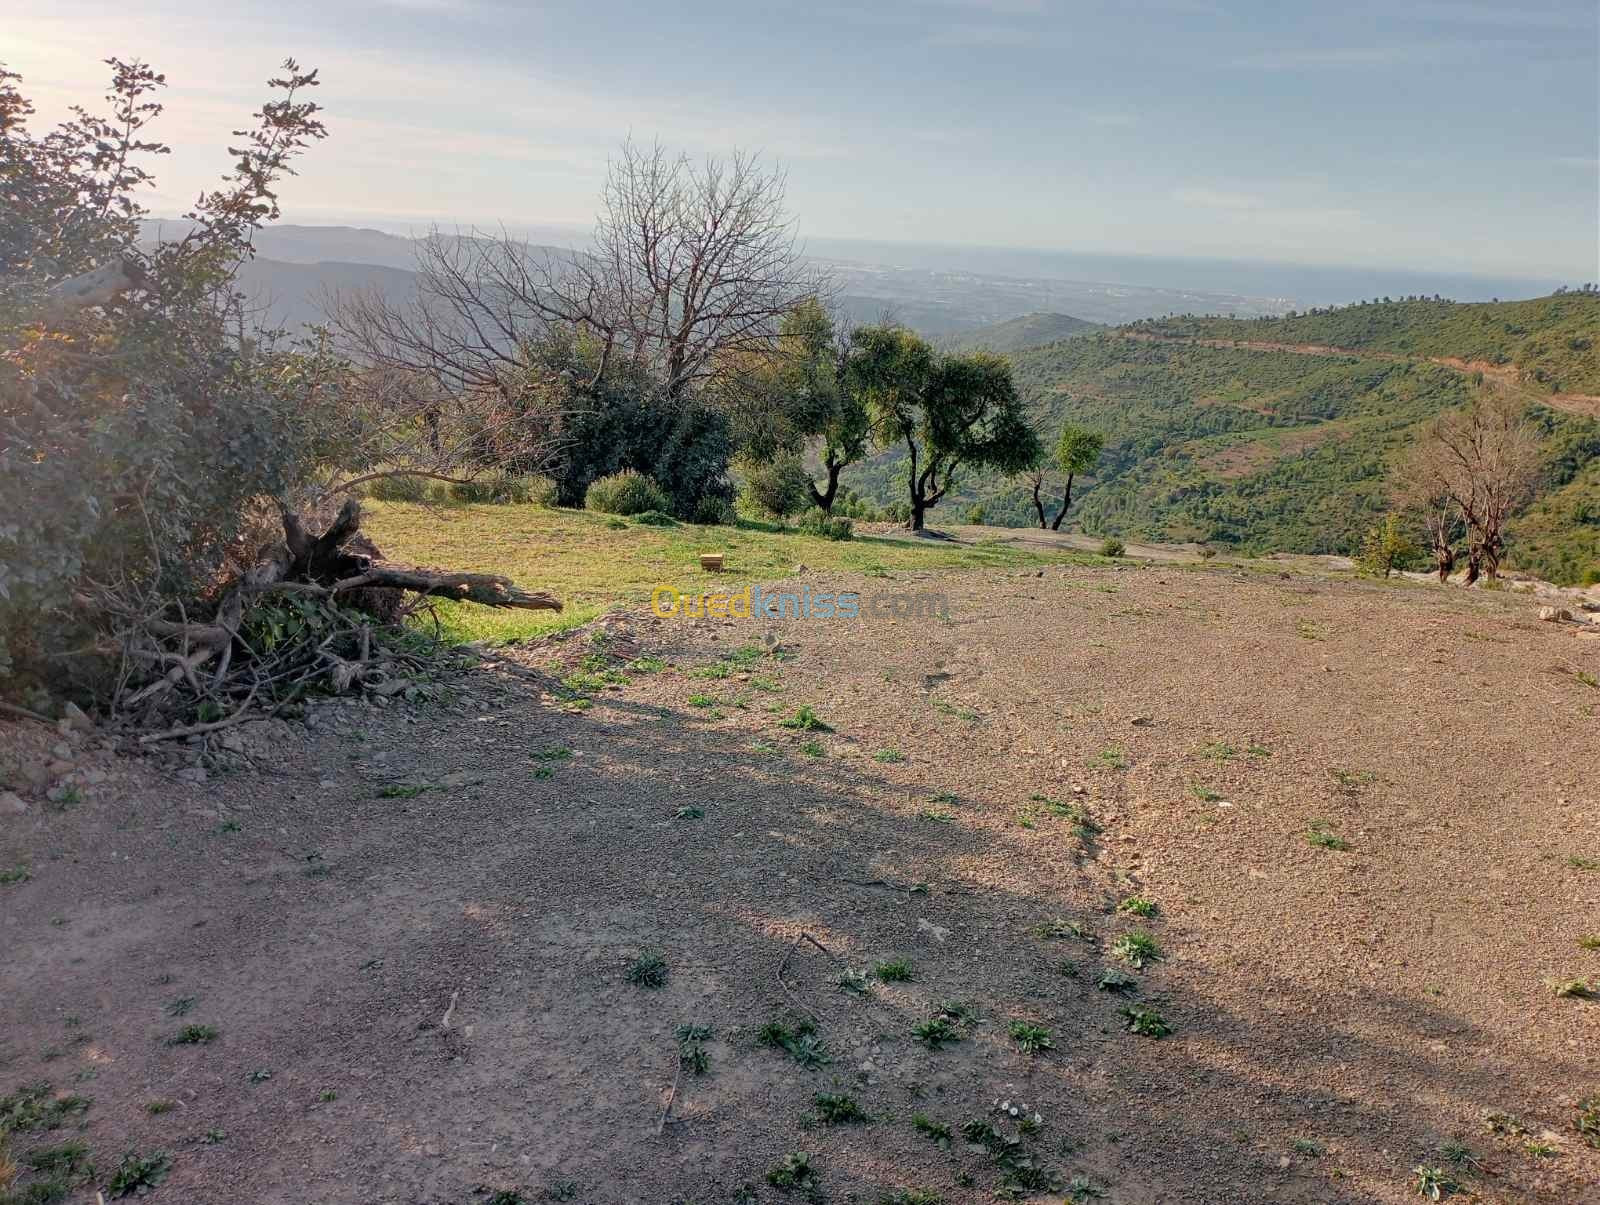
top-left (330, 142), bottom-right (826, 485)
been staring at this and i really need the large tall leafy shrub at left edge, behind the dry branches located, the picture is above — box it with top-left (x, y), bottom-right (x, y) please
top-left (0, 59), bottom-right (332, 695)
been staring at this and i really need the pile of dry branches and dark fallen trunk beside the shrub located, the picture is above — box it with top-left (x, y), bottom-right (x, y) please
top-left (112, 498), bottom-right (562, 744)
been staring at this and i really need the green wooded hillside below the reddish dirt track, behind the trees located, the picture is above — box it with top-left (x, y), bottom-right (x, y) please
top-left (846, 324), bottom-right (1600, 581)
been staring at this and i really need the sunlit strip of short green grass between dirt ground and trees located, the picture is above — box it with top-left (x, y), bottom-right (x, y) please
top-left (363, 501), bottom-right (1093, 643)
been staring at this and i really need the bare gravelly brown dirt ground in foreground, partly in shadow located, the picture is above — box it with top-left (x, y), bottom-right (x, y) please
top-left (0, 565), bottom-right (1600, 1205)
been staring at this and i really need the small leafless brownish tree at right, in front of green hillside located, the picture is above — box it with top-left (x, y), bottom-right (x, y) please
top-left (1405, 394), bottom-right (1539, 586)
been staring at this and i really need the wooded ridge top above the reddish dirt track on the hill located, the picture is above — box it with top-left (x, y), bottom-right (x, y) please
top-left (1130, 290), bottom-right (1600, 394)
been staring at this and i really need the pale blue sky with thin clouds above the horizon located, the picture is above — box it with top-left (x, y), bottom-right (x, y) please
top-left (0, 0), bottom-right (1600, 283)
